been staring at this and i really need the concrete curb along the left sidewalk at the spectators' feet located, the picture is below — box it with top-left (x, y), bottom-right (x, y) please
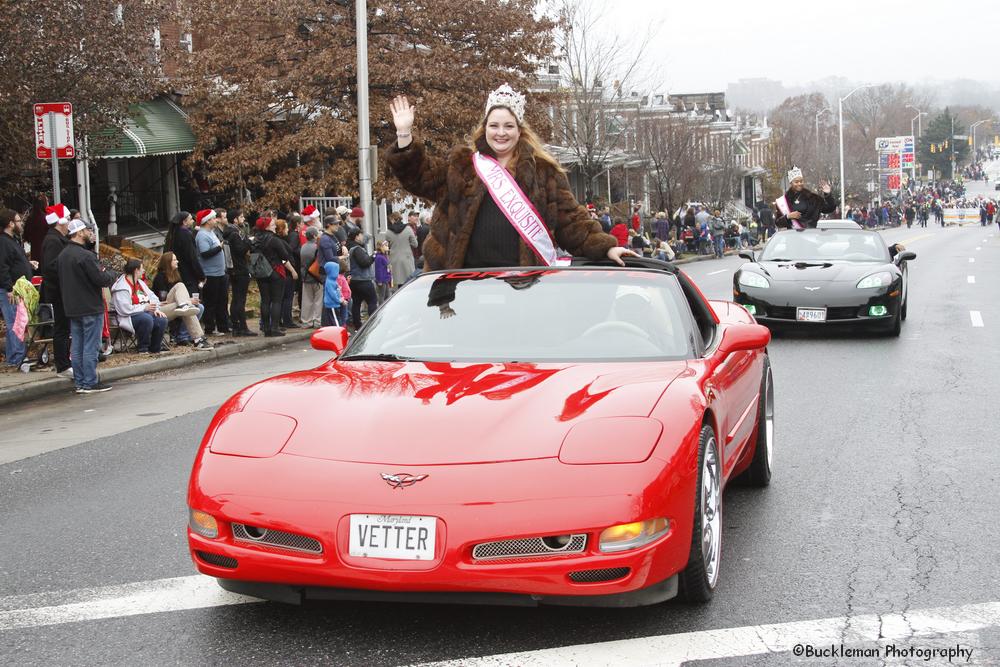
top-left (0, 329), bottom-right (313, 405)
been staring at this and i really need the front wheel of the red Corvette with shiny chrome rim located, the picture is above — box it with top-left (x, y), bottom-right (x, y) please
top-left (678, 424), bottom-right (722, 602)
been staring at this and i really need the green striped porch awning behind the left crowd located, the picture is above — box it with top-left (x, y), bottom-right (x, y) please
top-left (94, 97), bottom-right (195, 158)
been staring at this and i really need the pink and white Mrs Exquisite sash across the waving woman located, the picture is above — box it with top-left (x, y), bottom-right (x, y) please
top-left (472, 152), bottom-right (570, 266)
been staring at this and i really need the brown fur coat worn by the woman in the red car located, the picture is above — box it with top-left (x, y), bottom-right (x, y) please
top-left (386, 140), bottom-right (617, 271)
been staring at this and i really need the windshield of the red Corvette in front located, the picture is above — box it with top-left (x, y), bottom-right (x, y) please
top-left (340, 268), bottom-right (695, 362)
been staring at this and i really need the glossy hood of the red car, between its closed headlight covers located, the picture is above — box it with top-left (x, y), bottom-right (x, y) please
top-left (244, 361), bottom-right (687, 465)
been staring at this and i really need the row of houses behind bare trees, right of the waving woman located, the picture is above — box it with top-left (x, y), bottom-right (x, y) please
top-left (535, 65), bottom-right (771, 215)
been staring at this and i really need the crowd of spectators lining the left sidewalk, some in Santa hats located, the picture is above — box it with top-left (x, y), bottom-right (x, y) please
top-left (0, 204), bottom-right (430, 393)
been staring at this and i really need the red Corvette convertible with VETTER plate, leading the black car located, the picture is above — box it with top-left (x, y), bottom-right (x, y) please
top-left (188, 259), bottom-right (774, 606)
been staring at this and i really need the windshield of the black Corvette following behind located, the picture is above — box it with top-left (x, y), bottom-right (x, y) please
top-left (760, 229), bottom-right (890, 263)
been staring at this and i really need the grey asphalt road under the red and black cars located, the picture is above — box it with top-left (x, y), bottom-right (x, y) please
top-left (0, 226), bottom-right (1000, 665)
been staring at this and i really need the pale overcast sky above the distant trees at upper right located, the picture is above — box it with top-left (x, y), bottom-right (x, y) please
top-left (591, 0), bottom-right (1000, 93)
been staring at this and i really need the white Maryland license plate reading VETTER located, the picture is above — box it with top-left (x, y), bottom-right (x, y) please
top-left (349, 514), bottom-right (437, 560)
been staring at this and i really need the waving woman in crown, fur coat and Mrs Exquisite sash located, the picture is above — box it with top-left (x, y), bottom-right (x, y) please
top-left (387, 85), bottom-right (634, 268)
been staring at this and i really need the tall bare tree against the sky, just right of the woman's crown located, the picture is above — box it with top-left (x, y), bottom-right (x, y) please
top-left (553, 0), bottom-right (655, 197)
